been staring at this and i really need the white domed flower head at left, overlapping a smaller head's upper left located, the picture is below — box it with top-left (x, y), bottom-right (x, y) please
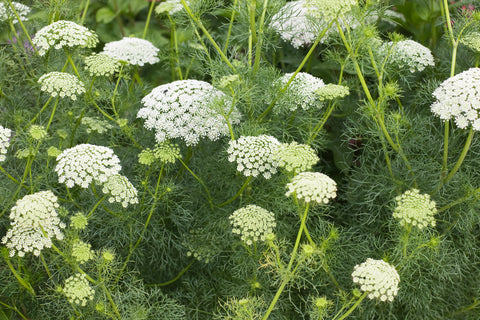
top-left (55, 144), bottom-right (121, 188)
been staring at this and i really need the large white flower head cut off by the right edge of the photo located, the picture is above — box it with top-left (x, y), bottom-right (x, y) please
top-left (430, 68), bottom-right (480, 131)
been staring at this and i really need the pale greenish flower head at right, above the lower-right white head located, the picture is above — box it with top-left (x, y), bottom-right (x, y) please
top-left (393, 189), bottom-right (437, 229)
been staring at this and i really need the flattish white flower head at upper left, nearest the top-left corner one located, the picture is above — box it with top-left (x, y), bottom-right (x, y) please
top-left (32, 20), bottom-right (98, 56)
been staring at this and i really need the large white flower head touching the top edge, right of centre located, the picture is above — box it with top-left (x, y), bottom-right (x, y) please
top-left (270, 0), bottom-right (318, 49)
